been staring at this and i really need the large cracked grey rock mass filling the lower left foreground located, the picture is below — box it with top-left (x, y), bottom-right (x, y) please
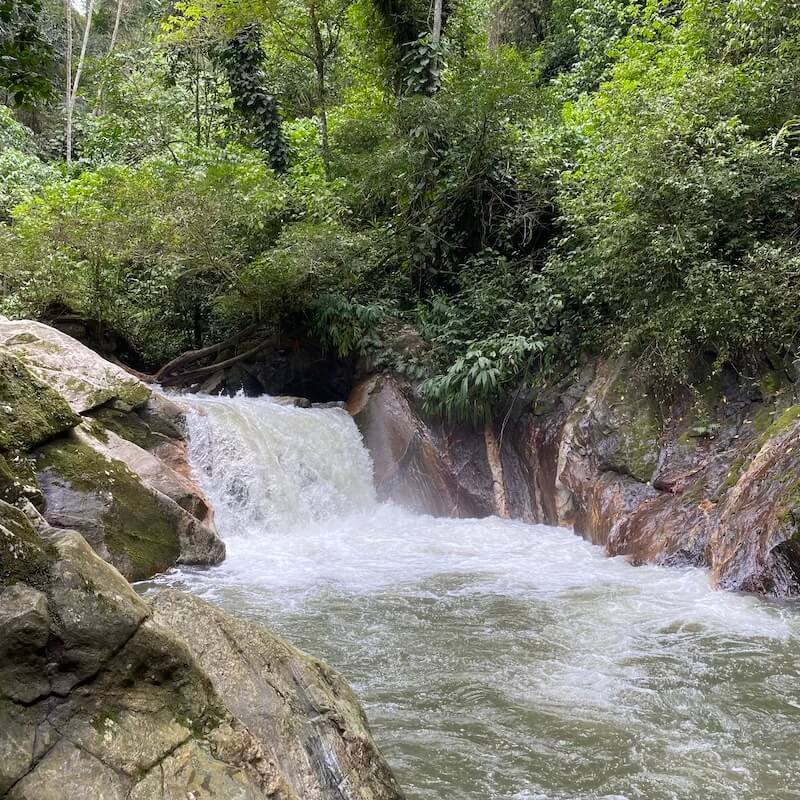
top-left (0, 502), bottom-right (401, 800)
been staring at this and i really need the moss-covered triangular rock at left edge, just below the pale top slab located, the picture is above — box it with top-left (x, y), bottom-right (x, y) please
top-left (0, 352), bottom-right (80, 450)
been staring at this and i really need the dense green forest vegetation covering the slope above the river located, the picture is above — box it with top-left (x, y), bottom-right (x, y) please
top-left (0, 0), bottom-right (800, 418)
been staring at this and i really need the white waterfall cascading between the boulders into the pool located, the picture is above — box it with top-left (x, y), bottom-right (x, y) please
top-left (189, 396), bottom-right (376, 537)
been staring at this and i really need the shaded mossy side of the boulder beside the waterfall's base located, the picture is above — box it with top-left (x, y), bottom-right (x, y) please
top-left (36, 436), bottom-right (180, 580)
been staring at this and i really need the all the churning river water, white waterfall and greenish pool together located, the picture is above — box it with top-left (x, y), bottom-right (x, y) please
top-left (152, 398), bottom-right (800, 800)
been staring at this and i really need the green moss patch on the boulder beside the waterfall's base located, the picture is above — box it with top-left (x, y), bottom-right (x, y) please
top-left (37, 439), bottom-right (180, 580)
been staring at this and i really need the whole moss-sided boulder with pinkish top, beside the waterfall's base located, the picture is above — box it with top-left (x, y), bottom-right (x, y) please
top-left (36, 424), bottom-right (225, 580)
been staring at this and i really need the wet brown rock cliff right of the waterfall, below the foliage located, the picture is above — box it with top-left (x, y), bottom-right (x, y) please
top-left (350, 362), bottom-right (800, 596)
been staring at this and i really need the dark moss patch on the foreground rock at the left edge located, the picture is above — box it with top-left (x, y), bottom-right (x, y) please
top-left (0, 502), bottom-right (57, 591)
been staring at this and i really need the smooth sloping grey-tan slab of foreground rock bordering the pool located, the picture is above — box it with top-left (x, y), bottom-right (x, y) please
top-left (152, 590), bottom-right (400, 800)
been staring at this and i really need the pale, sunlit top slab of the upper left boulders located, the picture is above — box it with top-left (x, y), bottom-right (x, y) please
top-left (0, 320), bottom-right (150, 414)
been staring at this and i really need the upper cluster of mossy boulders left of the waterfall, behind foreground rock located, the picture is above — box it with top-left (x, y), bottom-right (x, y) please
top-left (0, 320), bottom-right (225, 580)
